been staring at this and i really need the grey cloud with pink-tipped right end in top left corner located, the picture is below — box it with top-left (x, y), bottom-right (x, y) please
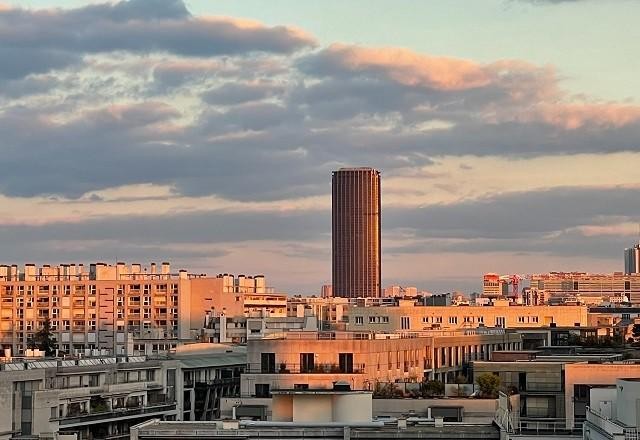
top-left (0, 0), bottom-right (315, 79)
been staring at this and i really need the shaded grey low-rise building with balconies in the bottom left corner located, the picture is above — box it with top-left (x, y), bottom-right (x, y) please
top-left (0, 356), bottom-right (177, 439)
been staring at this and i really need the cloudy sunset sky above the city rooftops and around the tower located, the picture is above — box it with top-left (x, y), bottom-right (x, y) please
top-left (0, 0), bottom-right (640, 294)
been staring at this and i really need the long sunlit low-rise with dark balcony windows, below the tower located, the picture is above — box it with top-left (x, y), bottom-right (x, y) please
top-left (241, 330), bottom-right (521, 397)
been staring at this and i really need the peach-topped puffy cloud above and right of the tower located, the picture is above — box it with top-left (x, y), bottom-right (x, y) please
top-left (298, 44), bottom-right (640, 130)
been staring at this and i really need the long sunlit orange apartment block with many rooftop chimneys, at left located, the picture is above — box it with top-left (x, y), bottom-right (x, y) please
top-left (0, 262), bottom-right (272, 355)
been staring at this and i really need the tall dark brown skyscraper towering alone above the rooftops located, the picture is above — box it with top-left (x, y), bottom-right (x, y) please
top-left (332, 168), bottom-right (381, 298)
